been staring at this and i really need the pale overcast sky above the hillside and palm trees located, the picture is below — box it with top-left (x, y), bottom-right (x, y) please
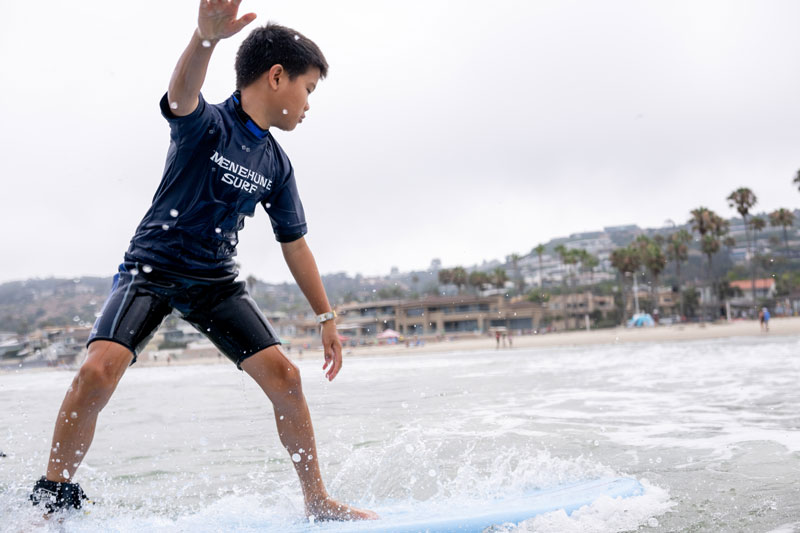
top-left (0, 0), bottom-right (800, 281)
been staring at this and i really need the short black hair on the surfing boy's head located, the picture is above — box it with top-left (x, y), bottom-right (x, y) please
top-left (236, 22), bottom-right (328, 89)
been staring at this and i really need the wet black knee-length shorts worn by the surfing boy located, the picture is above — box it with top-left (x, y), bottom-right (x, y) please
top-left (86, 260), bottom-right (280, 370)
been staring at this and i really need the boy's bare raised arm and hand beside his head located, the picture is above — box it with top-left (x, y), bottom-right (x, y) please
top-left (167, 0), bottom-right (256, 117)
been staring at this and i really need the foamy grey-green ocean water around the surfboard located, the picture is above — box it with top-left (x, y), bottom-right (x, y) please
top-left (0, 336), bottom-right (800, 533)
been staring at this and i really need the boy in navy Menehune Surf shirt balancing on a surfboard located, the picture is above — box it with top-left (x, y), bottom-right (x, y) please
top-left (31, 0), bottom-right (377, 520)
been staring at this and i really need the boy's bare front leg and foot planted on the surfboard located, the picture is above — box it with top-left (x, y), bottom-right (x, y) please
top-left (241, 345), bottom-right (377, 520)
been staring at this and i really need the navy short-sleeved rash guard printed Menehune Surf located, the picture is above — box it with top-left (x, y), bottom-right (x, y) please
top-left (126, 93), bottom-right (307, 276)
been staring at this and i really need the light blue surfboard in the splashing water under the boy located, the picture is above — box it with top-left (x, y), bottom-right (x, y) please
top-left (266, 478), bottom-right (644, 533)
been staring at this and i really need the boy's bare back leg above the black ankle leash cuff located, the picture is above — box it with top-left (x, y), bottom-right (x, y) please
top-left (46, 340), bottom-right (133, 482)
